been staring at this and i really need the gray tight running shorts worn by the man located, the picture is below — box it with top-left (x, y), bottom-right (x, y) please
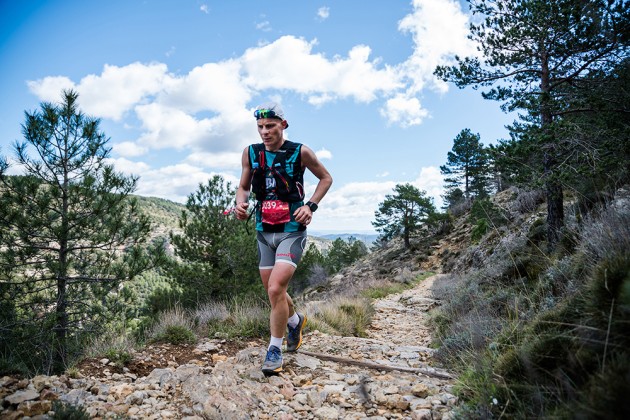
top-left (256, 230), bottom-right (306, 269)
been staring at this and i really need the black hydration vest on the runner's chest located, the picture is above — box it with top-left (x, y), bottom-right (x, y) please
top-left (249, 140), bottom-right (304, 203)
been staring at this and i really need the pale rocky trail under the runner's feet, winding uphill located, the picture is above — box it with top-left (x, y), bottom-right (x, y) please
top-left (0, 276), bottom-right (457, 420)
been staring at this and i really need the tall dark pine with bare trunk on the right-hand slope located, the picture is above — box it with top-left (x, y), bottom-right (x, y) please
top-left (436, 0), bottom-right (630, 244)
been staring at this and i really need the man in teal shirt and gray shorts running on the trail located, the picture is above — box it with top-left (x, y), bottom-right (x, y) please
top-left (235, 102), bottom-right (332, 375)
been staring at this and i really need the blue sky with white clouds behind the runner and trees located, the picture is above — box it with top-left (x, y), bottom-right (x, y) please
top-left (0, 0), bottom-right (514, 233)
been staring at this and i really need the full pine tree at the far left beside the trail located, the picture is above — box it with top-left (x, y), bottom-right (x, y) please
top-left (0, 91), bottom-right (163, 373)
